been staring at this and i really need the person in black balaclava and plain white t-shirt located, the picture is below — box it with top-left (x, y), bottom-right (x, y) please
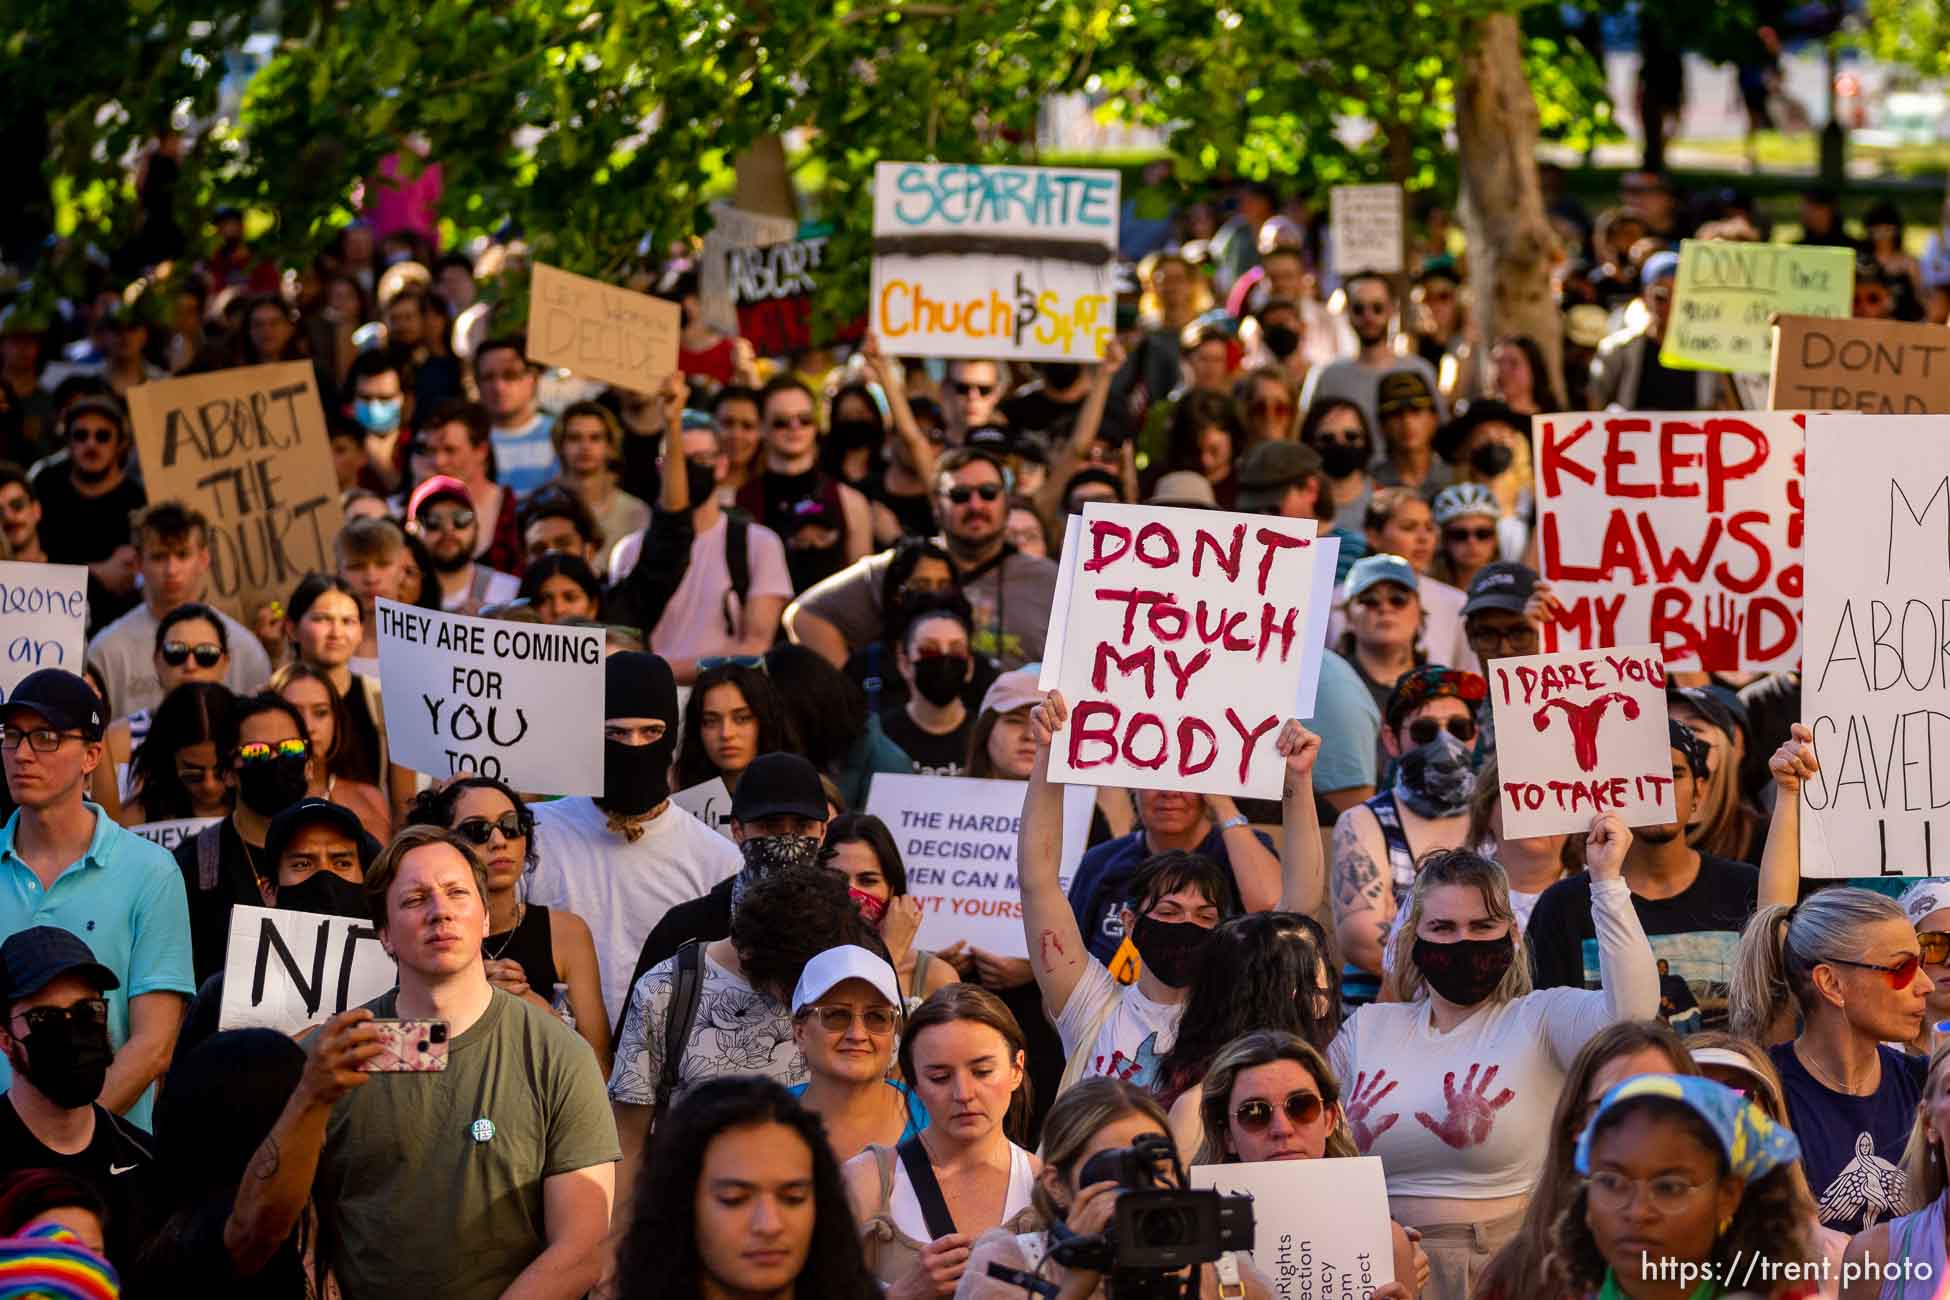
top-left (528, 651), bottom-right (741, 1025)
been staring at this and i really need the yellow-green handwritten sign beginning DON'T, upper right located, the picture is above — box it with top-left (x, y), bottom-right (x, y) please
top-left (1659, 240), bottom-right (1854, 374)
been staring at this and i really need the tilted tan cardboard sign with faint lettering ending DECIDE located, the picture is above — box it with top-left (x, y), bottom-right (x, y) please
top-left (528, 261), bottom-right (683, 392)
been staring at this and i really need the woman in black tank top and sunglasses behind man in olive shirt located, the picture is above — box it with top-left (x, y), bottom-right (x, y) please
top-left (406, 776), bottom-right (610, 1078)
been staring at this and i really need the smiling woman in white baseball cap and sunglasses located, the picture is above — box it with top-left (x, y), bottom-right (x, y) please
top-left (788, 943), bottom-right (928, 1164)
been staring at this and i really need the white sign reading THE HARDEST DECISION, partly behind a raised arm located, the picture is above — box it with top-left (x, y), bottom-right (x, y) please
top-left (866, 772), bottom-right (1096, 957)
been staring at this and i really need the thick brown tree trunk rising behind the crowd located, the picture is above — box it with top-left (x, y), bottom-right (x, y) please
top-left (1457, 14), bottom-right (1564, 403)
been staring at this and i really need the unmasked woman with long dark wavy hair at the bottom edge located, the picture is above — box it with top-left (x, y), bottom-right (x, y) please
top-left (612, 1078), bottom-right (881, 1300)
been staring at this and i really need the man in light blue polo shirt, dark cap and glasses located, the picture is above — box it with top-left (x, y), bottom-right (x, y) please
top-left (0, 669), bottom-right (195, 1127)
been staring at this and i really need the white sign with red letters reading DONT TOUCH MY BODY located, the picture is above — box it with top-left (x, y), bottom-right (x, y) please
top-left (1049, 501), bottom-right (1320, 799)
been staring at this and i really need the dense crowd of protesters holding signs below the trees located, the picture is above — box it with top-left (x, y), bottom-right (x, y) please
top-left (0, 134), bottom-right (1950, 1300)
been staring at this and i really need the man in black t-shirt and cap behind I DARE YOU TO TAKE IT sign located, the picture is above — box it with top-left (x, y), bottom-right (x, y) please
top-left (1523, 721), bottom-right (1761, 1029)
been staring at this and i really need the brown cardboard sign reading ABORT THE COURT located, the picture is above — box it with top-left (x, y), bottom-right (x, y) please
top-left (129, 361), bottom-right (343, 624)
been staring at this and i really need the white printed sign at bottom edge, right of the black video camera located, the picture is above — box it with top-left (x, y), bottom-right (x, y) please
top-left (1186, 1156), bottom-right (1394, 1300)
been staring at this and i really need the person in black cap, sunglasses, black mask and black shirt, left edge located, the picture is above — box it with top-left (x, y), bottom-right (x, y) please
top-left (0, 926), bottom-right (158, 1269)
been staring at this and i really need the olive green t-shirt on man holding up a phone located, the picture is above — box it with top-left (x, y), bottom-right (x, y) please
top-left (314, 988), bottom-right (620, 1300)
